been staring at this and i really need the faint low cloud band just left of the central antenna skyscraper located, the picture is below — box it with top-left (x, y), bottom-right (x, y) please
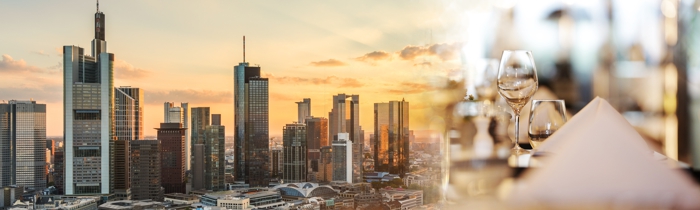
top-left (144, 89), bottom-right (233, 104)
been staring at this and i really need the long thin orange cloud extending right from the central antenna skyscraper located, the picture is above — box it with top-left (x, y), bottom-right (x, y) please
top-left (263, 73), bottom-right (364, 88)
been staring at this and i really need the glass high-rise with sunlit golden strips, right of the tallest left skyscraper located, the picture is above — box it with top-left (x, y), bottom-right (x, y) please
top-left (114, 86), bottom-right (144, 141)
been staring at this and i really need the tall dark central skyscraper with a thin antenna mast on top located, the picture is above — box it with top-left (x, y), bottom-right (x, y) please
top-left (233, 46), bottom-right (270, 187)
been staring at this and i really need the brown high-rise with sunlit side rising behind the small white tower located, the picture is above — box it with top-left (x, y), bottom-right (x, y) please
top-left (328, 93), bottom-right (364, 182)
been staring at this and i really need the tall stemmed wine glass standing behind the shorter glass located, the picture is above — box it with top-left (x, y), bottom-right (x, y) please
top-left (498, 50), bottom-right (538, 155)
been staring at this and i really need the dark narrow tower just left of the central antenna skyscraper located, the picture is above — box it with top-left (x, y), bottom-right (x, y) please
top-left (204, 119), bottom-right (226, 191)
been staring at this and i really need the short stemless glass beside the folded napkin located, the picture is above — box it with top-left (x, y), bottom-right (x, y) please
top-left (527, 100), bottom-right (566, 149)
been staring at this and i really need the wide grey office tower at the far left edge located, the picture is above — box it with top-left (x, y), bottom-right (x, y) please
top-left (0, 100), bottom-right (46, 190)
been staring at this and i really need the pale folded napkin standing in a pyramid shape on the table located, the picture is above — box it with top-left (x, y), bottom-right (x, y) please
top-left (508, 98), bottom-right (700, 209)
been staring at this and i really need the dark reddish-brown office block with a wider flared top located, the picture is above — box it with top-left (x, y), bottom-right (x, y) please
top-left (156, 123), bottom-right (187, 194)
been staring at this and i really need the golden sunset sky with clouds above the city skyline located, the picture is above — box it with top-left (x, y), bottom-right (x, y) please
top-left (0, 0), bottom-right (476, 137)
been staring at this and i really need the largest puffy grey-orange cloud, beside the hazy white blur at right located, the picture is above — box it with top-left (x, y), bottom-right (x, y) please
top-left (397, 43), bottom-right (462, 61)
